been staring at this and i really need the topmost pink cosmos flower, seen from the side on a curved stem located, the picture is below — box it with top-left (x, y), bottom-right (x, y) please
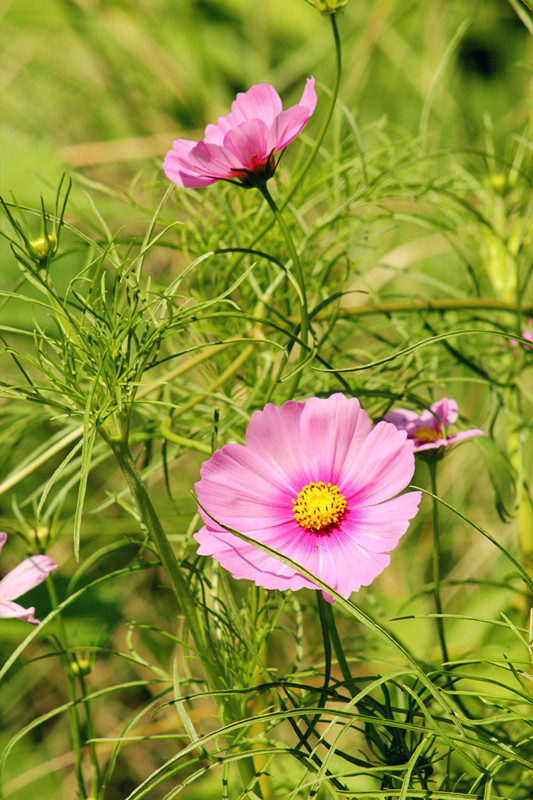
top-left (163, 78), bottom-right (316, 188)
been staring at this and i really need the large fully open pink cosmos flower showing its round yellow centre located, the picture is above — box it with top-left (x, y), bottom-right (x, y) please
top-left (195, 394), bottom-right (421, 600)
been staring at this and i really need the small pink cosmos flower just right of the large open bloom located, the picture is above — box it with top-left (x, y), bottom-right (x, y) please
top-left (384, 397), bottom-right (485, 452)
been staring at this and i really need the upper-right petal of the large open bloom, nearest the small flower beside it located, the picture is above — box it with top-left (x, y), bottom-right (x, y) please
top-left (339, 422), bottom-right (415, 505)
